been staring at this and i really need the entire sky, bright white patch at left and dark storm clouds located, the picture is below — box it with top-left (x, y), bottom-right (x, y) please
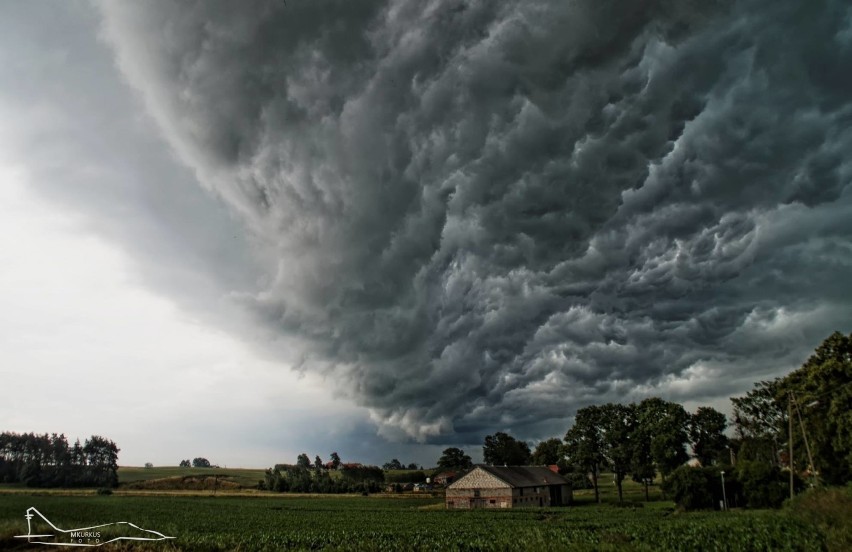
top-left (0, 0), bottom-right (852, 467)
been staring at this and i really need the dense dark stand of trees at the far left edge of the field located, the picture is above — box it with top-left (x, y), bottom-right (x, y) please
top-left (0, 432), bottom-right (119, 487)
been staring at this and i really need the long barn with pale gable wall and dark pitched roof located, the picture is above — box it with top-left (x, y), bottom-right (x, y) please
top-left (446, 466), bottom-right (572, 509)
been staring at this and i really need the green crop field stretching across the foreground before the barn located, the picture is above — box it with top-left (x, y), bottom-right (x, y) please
top-left (0, 494), bottom-right (825, 551)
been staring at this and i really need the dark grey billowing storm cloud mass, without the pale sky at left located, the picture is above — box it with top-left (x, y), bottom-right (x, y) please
top-left (96, 0), bottom-right (852, 442)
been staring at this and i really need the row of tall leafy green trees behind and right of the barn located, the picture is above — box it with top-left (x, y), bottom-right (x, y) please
top-left (438, 332), bottom-right (852, 504)
